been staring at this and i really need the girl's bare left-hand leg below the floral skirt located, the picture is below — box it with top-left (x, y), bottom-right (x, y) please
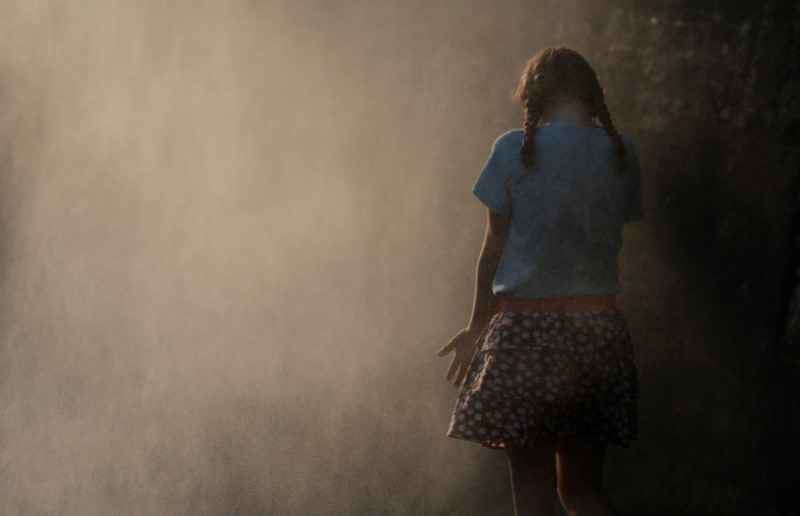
top-left (508, 443), bottom-right (556, 516)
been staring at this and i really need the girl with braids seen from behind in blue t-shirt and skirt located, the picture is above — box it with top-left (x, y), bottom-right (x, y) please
top-left (438, 47), bottom-right (642, 516)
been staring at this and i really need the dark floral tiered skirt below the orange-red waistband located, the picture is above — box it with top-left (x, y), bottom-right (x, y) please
top-left (447, 310), bottom-right (638, 449)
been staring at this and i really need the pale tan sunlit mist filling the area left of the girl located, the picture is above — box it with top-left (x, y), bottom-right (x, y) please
top-left (0, 0), bottom-right (796, 515)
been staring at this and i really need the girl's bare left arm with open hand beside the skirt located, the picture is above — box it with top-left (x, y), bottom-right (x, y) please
top-left (437, 211), bottom-right (510, 387)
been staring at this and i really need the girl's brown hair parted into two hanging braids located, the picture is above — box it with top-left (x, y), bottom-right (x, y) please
top-left (514, 47), bottom-right (626, 170)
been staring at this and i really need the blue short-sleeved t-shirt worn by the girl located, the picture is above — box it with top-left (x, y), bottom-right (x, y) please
top-left (472, 122), bottom-right (643, 298)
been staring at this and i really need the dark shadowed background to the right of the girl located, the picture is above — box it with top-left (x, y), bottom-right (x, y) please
top-left (580, 2), bottom-right (800, 515)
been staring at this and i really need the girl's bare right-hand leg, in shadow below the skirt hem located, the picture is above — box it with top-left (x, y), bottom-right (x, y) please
top-left (556, 438), bottom-right (617, 516)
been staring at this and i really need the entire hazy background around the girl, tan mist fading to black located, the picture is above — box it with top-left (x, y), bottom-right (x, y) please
top-left (0, 0), bottom-right (800, 516)
